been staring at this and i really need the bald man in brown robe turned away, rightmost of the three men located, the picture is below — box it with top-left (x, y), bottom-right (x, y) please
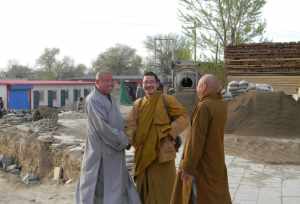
top-left (171, 75), bottom-right (231, 204)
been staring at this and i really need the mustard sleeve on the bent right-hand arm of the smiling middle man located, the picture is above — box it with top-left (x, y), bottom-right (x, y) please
top-left (165, 95), bottom-right (189, 138)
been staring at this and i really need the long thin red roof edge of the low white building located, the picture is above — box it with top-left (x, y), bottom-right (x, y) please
top-left (0, 80), bottom-right (94, 85)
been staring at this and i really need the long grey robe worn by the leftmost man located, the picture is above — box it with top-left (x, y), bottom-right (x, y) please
top-left (76, 89), bottom-right (139, 204)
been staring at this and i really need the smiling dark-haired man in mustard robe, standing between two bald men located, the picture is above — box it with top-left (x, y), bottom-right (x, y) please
top-left (126, 72), bottom-right (189, 204)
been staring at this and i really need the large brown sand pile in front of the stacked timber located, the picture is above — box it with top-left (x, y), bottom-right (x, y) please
top-left (226, 92), bottom-right (300, 138)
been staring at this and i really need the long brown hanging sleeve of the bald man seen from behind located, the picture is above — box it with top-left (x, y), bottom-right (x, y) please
top-left (181, 104), bottom-right (211, 175)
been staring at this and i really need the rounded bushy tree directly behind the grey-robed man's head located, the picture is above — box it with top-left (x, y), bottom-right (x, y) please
top-left (92, 44), bottom-right (142, 75)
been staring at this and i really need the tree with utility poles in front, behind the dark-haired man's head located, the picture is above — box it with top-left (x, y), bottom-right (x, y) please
top-left (144, 34), bottom-right (192, 74)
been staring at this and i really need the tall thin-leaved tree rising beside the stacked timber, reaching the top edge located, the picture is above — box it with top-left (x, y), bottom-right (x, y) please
top-left (179, 0), bottom-right (266, 59)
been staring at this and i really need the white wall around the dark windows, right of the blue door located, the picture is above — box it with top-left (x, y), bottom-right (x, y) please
top-left (31, 84), bottom-right (94, 107)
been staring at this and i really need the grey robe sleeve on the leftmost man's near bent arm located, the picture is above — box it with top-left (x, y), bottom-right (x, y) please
top-left (86, 97), bottom-right (128, 151)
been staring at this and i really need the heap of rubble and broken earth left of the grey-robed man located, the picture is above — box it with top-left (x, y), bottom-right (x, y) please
top-left (0, 109), bottom-right (134, 184)
